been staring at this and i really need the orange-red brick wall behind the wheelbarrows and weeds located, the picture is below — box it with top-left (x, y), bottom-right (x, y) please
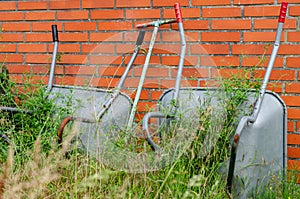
top-left (0, 0), bottom-right (300, 171)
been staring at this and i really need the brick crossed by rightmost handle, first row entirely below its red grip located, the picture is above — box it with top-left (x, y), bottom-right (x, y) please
top-left (243, 32), bottom-right (285, 42)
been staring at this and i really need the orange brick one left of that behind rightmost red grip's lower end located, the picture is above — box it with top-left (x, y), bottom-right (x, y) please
top-left (212, 19), bottom-right (251, 30)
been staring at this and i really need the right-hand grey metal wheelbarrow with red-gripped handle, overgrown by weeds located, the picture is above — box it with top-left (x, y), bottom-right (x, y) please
top-left (143, 2), bottom-right (287, 198)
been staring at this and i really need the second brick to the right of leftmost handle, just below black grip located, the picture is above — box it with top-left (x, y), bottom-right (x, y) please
top-left (82, 43), bottom-right (115, 54)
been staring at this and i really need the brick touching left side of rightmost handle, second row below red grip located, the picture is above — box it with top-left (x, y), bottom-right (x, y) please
top-left (232, 44), bottom-right (272, 55)
